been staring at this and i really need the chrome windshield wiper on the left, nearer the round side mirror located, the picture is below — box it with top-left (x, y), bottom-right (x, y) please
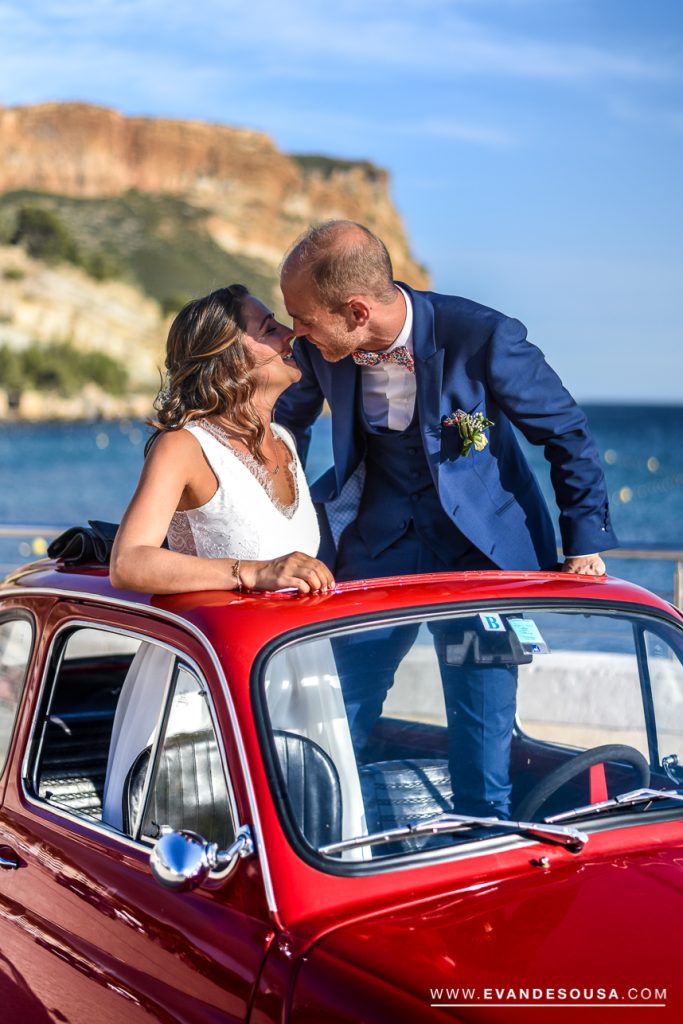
top-left (318, 814), bottom-right (588, 854)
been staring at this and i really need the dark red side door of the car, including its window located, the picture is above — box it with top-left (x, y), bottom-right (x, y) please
top-left (0, 603), bottom-right (271, 1024)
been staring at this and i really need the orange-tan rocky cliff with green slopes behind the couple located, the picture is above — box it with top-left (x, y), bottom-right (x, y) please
top-left (0, 103), bottom-right (428, 417)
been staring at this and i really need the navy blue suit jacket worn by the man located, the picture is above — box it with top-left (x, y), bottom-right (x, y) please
top-left (275, 284), bottom-right (617, 569)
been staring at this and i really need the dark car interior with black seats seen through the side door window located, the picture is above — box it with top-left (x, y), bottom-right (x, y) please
top-left (30, 630), bottom-right (233, 847)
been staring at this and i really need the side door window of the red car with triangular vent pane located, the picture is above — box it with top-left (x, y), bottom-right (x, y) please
top-left (30, 628), bottom-right (231, 841)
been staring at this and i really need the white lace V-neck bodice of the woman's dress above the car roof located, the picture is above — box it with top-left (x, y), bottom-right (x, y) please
top-left (168, 420), bottom-right (321, 559)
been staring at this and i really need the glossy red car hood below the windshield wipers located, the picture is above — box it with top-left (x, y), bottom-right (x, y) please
top-left (292, 835), bottom-right (683, 1022)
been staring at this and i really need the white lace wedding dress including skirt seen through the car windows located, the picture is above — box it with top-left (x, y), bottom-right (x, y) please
top-left (102, 421), bottom-right (365, 859)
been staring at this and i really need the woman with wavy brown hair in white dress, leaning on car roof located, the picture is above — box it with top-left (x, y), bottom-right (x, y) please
top-left (110, 285), bottom-right (335, 594)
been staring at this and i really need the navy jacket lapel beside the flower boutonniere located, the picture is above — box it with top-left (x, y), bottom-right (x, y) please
top-left (409, 285), bottom-right (444, 490)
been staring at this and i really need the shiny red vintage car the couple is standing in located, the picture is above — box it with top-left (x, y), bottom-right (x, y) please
top-left (0, 562), bottom-right (683, 1024)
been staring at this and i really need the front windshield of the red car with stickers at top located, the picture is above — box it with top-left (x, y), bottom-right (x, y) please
top-left (263, 605), bottom-right (683, 863)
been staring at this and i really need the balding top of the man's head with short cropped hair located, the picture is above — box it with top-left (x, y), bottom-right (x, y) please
top-left (281, 220), bottom-right (396, 311)
